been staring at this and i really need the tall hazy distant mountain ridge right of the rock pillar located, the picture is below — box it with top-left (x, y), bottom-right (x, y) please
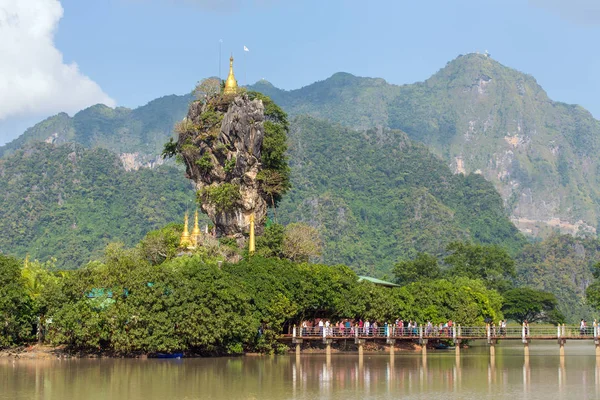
top-left (253, 54), bottom-right (600, 235)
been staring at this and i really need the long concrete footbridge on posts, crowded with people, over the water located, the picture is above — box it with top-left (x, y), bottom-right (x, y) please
top-left (280, 324), bottom-right (600, 357)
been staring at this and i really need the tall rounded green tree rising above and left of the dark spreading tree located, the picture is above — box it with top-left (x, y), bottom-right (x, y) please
top-left (444, 242), bottom-right (515, 291)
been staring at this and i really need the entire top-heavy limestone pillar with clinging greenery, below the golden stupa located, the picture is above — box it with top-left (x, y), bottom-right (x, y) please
top-left (163, 86), bottom-right (290, 238)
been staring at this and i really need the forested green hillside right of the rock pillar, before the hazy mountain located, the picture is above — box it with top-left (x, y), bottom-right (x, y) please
top-left (278, 117), bottom-right (525, 275)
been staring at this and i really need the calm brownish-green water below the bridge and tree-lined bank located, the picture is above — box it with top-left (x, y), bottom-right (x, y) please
top-left (0, 341), bottom-right (600, 400)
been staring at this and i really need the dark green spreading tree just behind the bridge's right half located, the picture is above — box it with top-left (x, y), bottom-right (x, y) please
top-left (502, 287), bottom-right (564, 323)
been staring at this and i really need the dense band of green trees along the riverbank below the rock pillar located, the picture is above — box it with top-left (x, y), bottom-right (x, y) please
top-left (0, 225), bottom-right (556, 355)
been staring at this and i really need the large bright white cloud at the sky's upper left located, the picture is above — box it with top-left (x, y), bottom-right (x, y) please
top-left (0, 0), bottom-right (115, 120)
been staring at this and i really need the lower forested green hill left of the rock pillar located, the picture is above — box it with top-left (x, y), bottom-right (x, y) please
top-left (0, 143), bottom-right (194, 268)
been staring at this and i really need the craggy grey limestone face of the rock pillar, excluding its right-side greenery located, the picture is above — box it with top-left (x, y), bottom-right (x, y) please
top-left (178, 95), bottom-right (267, 238)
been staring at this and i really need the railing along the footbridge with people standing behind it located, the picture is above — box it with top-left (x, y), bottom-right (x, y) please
top-left (292, 325), bottom-right (600, 339)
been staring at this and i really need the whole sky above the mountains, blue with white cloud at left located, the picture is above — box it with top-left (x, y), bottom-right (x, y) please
top-left (0, 0), bottom-right (600, 144)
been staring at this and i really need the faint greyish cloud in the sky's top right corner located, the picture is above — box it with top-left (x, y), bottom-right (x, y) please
top-left (529, 0), bottom-right (600, 25)
